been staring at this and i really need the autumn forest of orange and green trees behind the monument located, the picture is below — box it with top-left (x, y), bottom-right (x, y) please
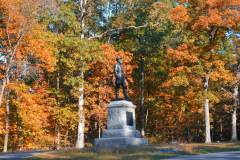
top-left (0, 0), bottom-right (240, 152)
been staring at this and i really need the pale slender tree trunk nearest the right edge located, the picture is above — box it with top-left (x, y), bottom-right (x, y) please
top-left (231, 61), bottom-right (240, 141)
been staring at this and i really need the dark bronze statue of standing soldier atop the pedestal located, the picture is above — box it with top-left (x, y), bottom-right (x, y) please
top-left (114, 56), bottom-right (131, 100)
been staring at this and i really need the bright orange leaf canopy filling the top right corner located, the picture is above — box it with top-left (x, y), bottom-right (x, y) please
top-left (169, 0), bottom-right (240, 31)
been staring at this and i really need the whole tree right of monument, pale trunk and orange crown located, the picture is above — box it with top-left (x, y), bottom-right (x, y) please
top-left (169, 0), bottom-right (239, 143)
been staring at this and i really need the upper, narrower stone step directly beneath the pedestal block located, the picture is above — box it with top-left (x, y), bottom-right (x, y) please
top-left (102, 129), bottom-right (141, 138)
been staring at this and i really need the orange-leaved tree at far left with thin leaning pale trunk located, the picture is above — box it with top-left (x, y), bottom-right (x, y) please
top-left (0, 0), bottom-right (55, 152)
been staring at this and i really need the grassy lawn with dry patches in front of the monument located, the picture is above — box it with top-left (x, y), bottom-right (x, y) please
top-left (25, 142), bottom-right (240, 160)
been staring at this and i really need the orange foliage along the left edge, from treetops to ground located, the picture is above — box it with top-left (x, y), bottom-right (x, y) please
top-left (0, 0), bottom-right (56, 150)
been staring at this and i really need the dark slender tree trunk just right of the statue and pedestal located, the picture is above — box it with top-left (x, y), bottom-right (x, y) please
top-left (141, 57), bottom-right (145, 137)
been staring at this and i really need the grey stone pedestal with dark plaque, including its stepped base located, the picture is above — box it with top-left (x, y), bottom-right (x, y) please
top-left (94, 100), bottom-right (148, 148)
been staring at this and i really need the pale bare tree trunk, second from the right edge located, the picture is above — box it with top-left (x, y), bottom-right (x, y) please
top-left (203, 68), bottom-right (211, 143)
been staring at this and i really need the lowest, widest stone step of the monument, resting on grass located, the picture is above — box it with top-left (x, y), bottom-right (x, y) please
top-left (94, 137), bottom-right (148, 148)
